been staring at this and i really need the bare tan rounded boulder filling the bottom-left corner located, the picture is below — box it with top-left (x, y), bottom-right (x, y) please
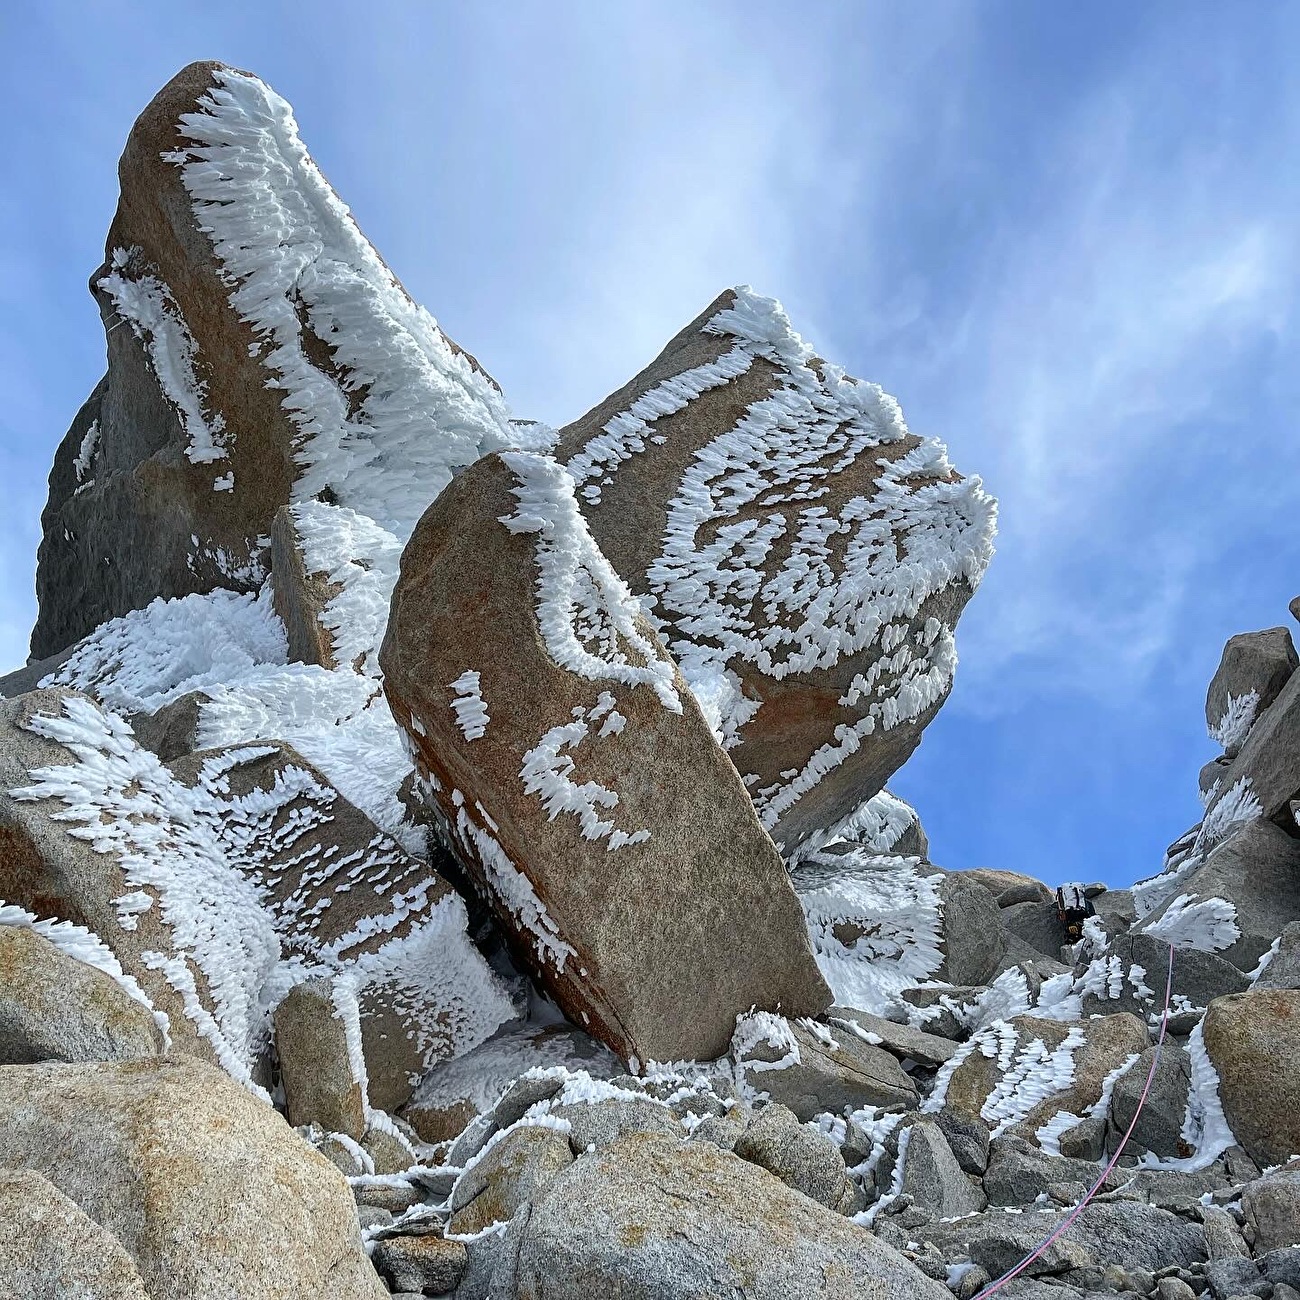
top-left (0, 1169), bottom-right (151, 1300)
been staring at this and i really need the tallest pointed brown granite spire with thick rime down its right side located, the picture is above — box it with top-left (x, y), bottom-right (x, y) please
top-left (31, 62), bottom-right (516, 659)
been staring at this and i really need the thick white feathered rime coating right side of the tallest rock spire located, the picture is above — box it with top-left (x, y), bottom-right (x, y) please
top-left (170, 69), bottom-right (533, 538)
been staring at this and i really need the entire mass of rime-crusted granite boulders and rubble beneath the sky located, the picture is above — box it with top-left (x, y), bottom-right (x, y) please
top-left (0, 64), bottom-right (1300, 1300)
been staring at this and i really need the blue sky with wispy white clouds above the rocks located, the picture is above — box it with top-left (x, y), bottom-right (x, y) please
top-left (0, 0), bottom-right (1300, 883)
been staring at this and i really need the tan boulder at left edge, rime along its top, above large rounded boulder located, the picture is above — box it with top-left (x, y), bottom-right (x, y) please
top-left (0, 925), bottom-right (164, 1065)
